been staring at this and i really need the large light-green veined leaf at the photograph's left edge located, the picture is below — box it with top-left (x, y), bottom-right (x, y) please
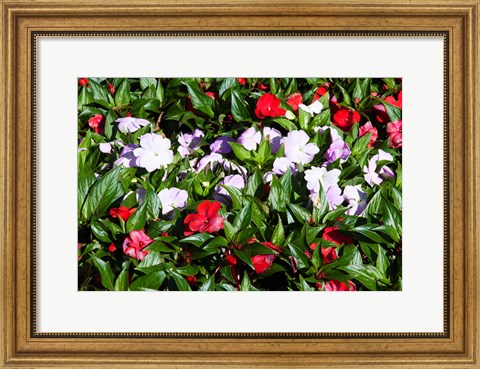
top-left (82, 167), bottom-right (125, 219)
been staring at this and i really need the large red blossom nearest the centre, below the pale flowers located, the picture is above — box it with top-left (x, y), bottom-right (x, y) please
top-left (184, 200), bottom-right (223, 236)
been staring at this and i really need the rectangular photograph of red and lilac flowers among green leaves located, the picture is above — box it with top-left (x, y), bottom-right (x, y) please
top-left (77, 77), bottom-right (402, 292)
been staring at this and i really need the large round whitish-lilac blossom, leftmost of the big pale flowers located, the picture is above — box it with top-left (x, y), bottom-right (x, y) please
top-left (133, 133), bottom-right (173, 172)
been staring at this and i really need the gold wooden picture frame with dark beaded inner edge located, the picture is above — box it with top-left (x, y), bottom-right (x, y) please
top-left (0, 0), bottom-right (480, 369)
